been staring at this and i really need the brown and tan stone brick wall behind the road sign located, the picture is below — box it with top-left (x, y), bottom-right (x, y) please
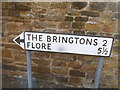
top-left (0, 2), bottom-right (120, 88)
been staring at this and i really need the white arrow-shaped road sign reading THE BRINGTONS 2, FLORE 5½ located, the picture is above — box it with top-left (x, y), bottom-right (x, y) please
top-left (13, 32), bottom-right (113, 56)
